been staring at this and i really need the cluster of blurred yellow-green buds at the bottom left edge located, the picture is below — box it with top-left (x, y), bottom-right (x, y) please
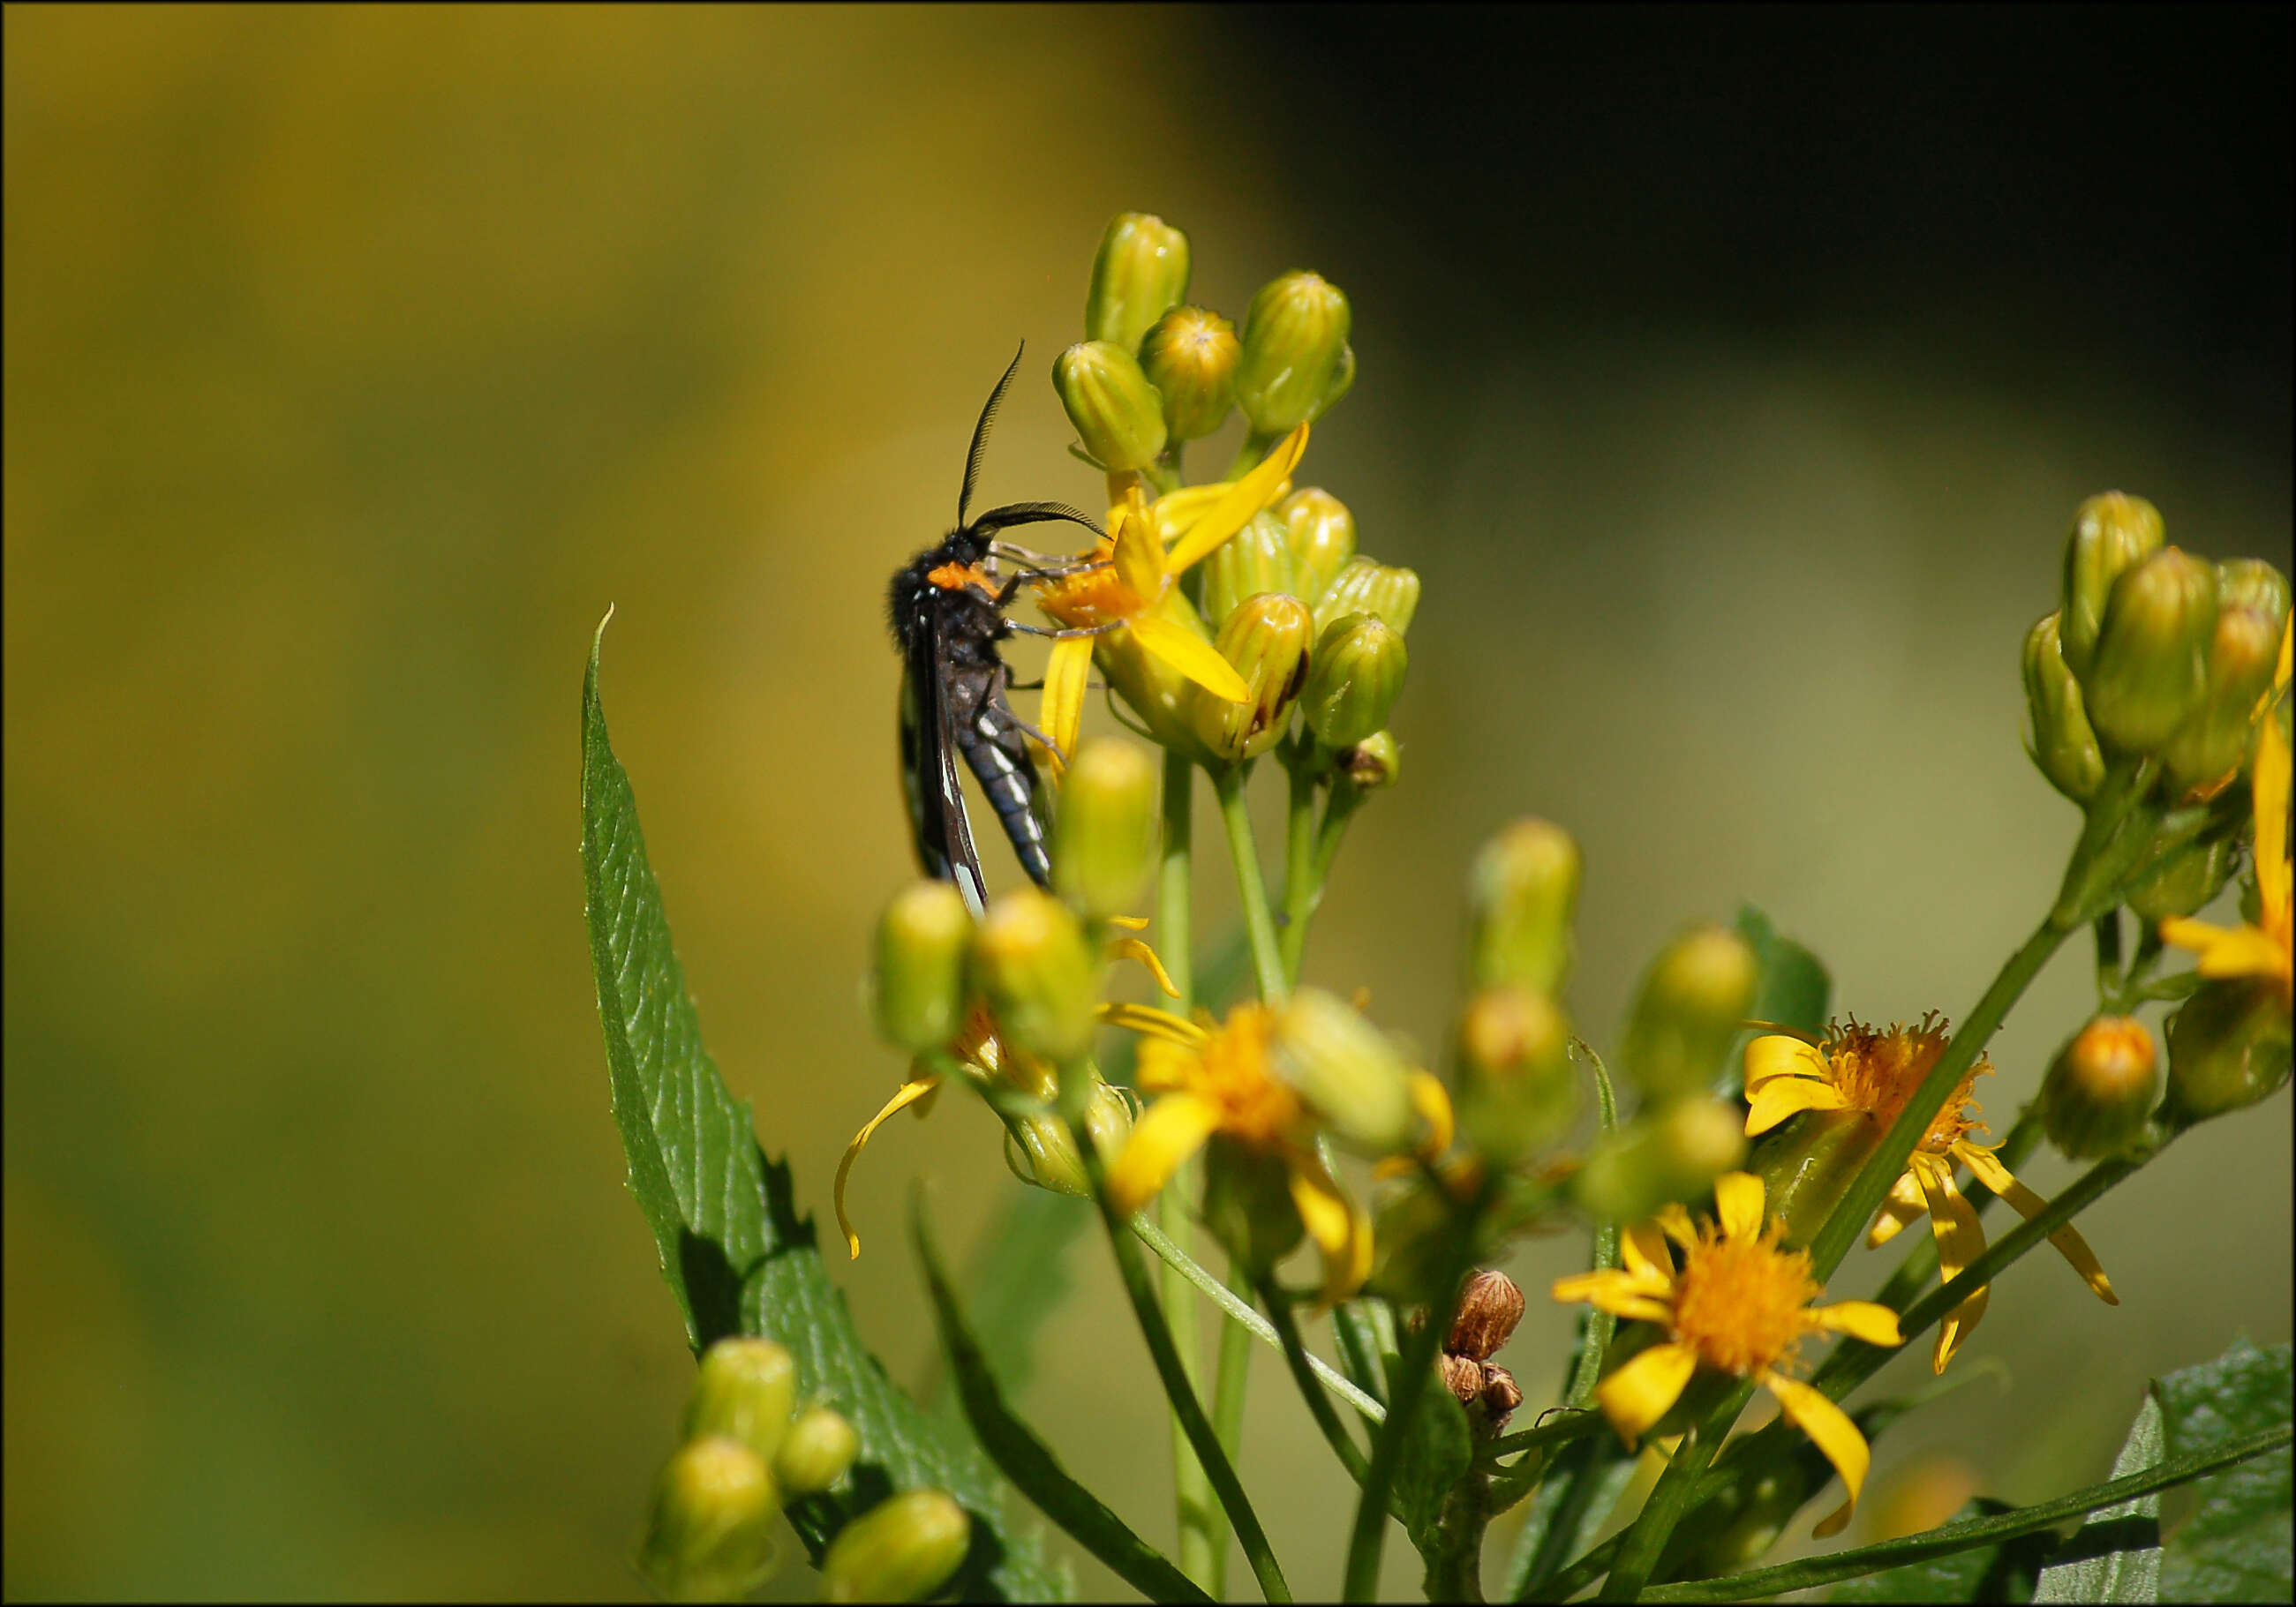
top-left (638, 1339), bottom-right (950, 1603)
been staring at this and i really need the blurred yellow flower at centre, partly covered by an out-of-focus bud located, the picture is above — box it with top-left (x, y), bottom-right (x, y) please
top-left (1107, 1003), bottom-right (1371, 1304)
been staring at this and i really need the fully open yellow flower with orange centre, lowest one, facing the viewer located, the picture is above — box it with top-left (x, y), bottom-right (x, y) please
top-left (1555, 1171), bottom-right (1906, 1538)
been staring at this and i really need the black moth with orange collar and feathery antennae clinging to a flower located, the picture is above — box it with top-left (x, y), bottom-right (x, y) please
top-left (886, 347), bottom-right (1100, 916)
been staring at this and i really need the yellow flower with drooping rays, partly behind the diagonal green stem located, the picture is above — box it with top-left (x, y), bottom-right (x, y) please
top-left (1745, 1015), bottom-right (2121, 1373)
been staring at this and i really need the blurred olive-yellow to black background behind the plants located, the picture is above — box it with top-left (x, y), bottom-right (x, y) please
top-left (4, 7), bottom-right (2289, 1598)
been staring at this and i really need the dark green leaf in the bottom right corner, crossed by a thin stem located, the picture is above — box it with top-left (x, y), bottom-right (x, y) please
top-left (2154, 1340), bottom-right (2292, 1603)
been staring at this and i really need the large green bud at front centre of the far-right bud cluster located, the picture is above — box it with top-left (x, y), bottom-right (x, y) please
top-left (2081, 546), bottom-right (2216, 753)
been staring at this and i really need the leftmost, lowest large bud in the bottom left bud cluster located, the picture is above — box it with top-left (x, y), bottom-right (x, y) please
top-left (638, 1435), bottom-right (780, 1603)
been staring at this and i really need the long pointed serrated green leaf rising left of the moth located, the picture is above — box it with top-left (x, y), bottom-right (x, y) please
top-left (581, 622), bottom-right (1065, 1600)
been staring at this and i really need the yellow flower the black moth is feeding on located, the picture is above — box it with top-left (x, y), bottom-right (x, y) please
top-left (1035, 424), bottom-right (1306, 753)
